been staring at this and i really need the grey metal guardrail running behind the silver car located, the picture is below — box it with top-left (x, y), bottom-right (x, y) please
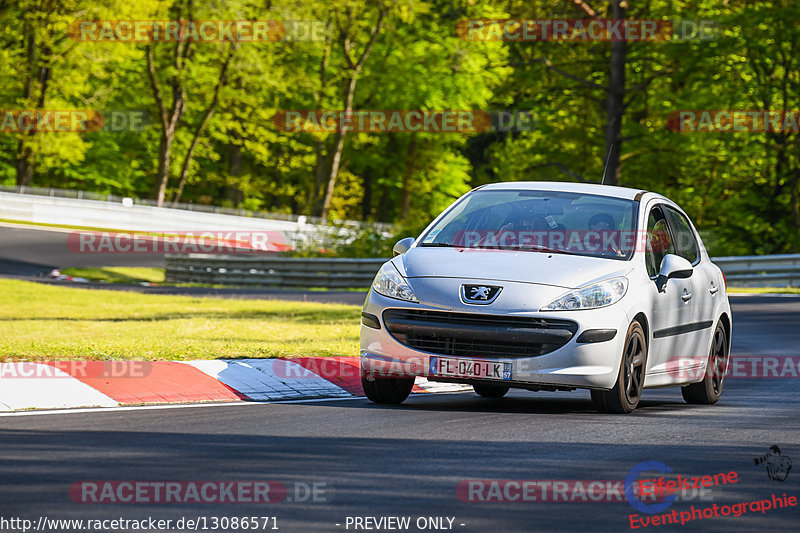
top-left (166, 254), bottom-right (800, 289)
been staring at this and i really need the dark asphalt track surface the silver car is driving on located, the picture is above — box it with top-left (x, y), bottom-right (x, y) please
top-left (0, 297), bottom-right (800, 533)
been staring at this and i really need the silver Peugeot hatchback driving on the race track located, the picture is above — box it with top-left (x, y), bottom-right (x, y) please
top-left (361, 182), bottom-right (732, 413)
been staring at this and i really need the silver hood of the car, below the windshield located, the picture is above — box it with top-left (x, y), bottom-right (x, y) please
top-left (394, 247), bottom-right (633, 289)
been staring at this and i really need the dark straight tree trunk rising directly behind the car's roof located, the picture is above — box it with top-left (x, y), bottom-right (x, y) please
top-left (603, 0), bottom-right (627, 185)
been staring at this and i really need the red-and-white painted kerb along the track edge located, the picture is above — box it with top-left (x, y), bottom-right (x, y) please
top-left (0, 357), bottom-right (469, 412)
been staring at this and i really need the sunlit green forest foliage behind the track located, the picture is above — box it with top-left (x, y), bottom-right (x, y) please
top-left (0, 0), bottom-right (800, 257)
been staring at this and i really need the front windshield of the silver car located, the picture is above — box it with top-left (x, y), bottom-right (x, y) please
top-left (420, 190), bottom-right (636, 259)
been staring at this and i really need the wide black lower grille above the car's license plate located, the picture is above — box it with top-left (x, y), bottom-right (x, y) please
top-left (383, 309), bottom-right (578, 358)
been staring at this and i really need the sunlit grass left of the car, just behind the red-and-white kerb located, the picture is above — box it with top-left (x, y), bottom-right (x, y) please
top-left (0, 280), bottom-right (360, 361)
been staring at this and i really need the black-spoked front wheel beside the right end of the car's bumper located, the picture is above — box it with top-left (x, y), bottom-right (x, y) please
top-left (592, 320), bottom-right (647, 414)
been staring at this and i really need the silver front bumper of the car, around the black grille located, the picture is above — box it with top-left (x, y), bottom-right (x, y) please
top-left (361, 280), bottom-right (630, 389)
